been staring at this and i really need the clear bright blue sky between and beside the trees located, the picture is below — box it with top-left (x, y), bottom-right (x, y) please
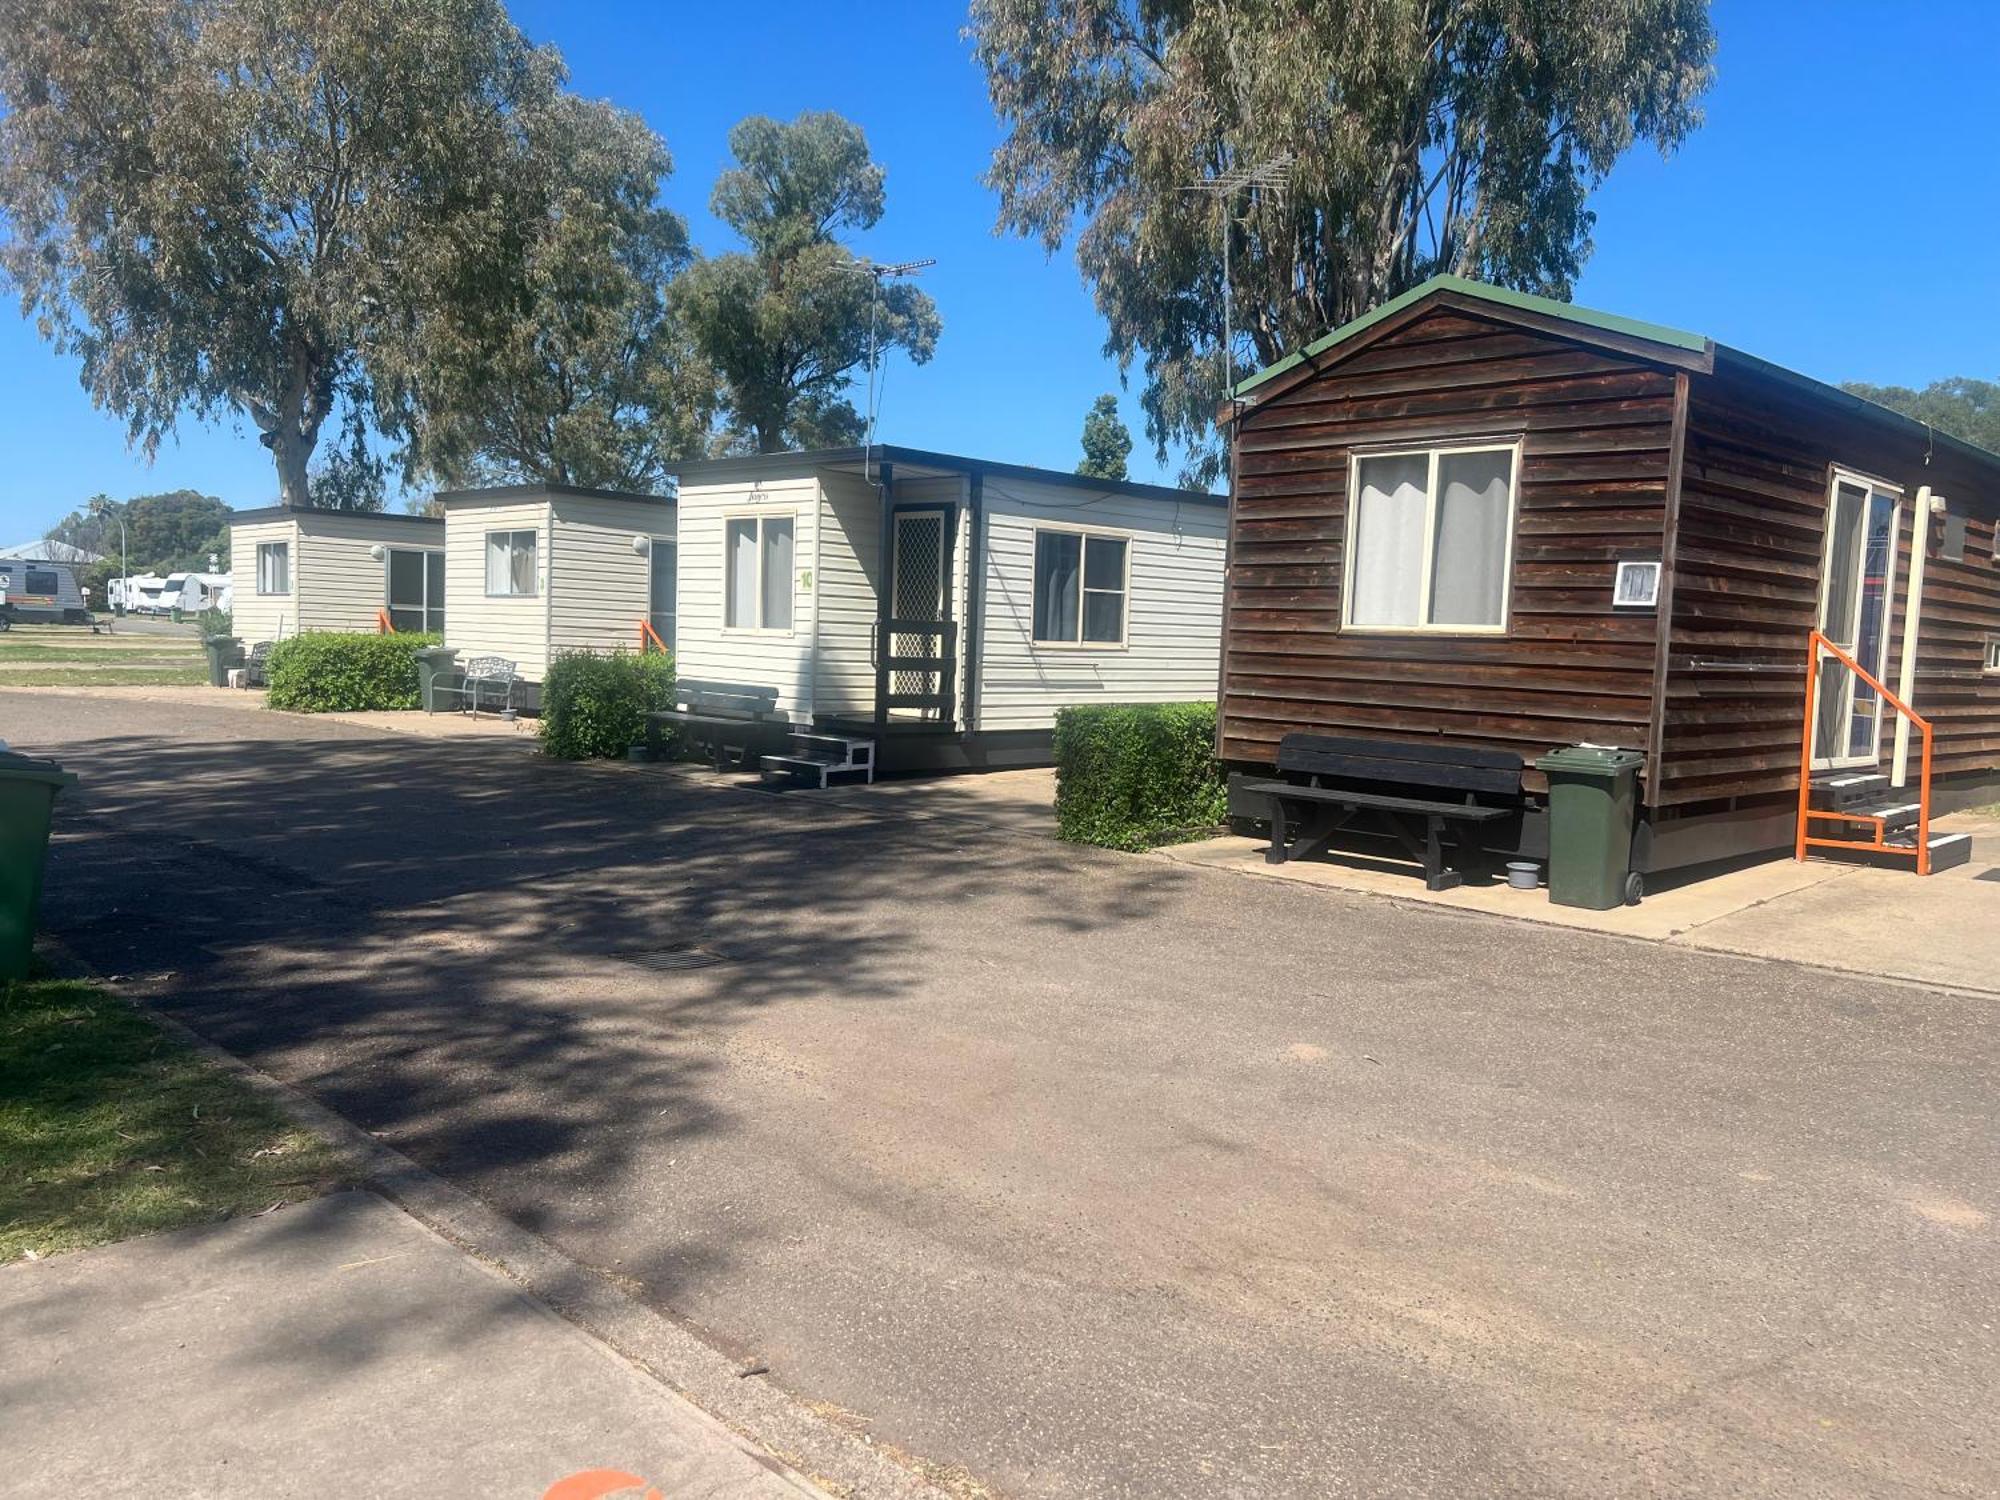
top-left (0, 0), bottom-right (2000, 544)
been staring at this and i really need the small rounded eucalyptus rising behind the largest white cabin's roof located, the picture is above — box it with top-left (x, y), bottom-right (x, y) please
top-left (672, 112), bottom-right (940, 452)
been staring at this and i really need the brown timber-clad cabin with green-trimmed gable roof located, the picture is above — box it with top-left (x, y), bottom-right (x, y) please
top-left (1218, 276), bottom-right (2000, 870)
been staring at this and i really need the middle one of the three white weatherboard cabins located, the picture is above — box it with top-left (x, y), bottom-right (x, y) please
top-left (438, 484), bottom-right (674, 684)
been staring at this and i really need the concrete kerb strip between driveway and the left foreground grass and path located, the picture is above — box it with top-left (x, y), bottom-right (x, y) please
top-left (36, 934), bottom-right (968, 1500)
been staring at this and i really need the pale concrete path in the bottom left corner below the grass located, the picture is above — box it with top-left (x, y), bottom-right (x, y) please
top-left (0, 1192), bottom-right (822, 1500)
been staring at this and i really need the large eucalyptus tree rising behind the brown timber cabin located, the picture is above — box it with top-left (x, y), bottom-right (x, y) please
top-left (968, 0), bottom-right (1714, 480)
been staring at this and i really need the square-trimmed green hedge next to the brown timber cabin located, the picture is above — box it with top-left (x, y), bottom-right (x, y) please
top-left (1056, 704), bottom-right (1228, 850)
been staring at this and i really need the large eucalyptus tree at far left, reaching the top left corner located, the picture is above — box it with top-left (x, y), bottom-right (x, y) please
top-left (0, 0), bottom-right (560, 504)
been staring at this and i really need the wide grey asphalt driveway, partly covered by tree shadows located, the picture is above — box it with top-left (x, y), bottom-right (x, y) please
top-left (15, 694), bottom-right (2000, 1496)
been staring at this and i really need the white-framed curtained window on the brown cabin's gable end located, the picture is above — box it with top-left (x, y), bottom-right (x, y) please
top-left (1342, 444), bottom-right (1520, 634)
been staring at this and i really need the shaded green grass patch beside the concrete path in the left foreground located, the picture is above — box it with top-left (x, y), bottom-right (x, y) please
top-left (0, 978), bottom-right (350, 1264)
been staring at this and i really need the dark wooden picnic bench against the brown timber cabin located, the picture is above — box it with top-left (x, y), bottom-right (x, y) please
top-left (1242, 734), bottom-right (1522, 890)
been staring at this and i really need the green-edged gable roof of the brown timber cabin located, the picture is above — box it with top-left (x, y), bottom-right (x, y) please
top-left (1220, 276), bottom-right (2000, 478)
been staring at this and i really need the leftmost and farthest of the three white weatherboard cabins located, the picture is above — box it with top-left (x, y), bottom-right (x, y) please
top-left (230, 506), bottom-right (444, 644)
